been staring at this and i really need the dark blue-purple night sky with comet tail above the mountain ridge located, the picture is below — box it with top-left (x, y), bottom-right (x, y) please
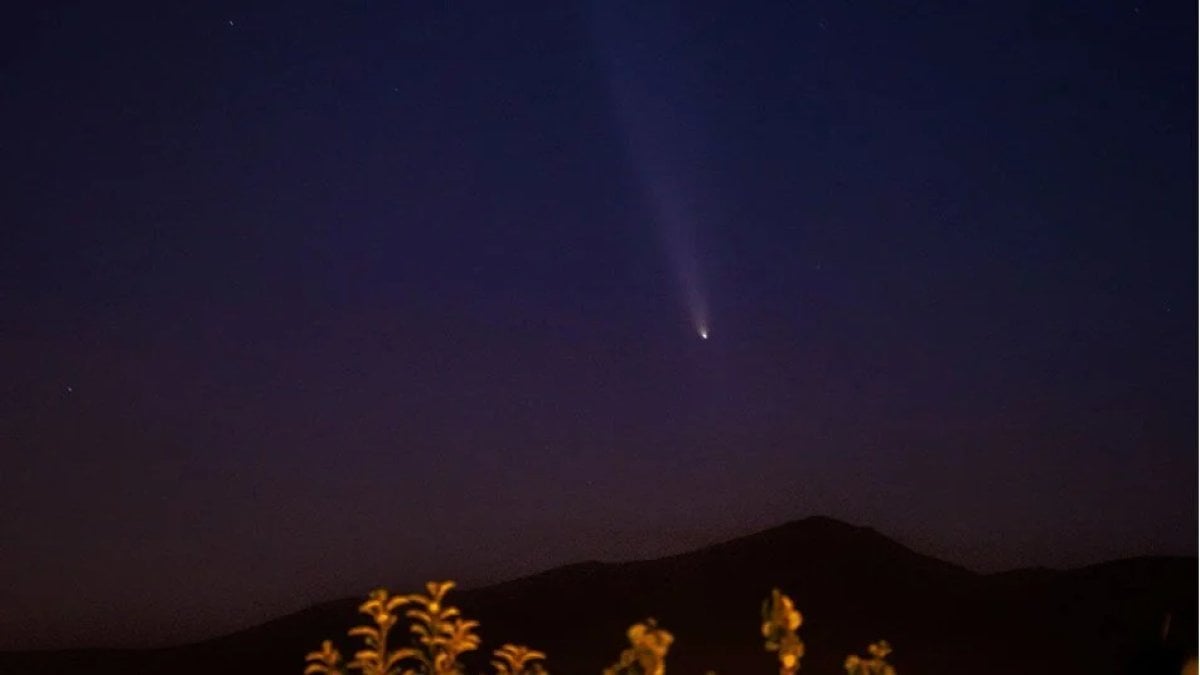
top-left (0, 0), bottom-right (1198, 647)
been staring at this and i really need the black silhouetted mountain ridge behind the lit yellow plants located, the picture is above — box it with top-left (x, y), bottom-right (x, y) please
top-left (0, 518), bottom-right (1196, 675)
